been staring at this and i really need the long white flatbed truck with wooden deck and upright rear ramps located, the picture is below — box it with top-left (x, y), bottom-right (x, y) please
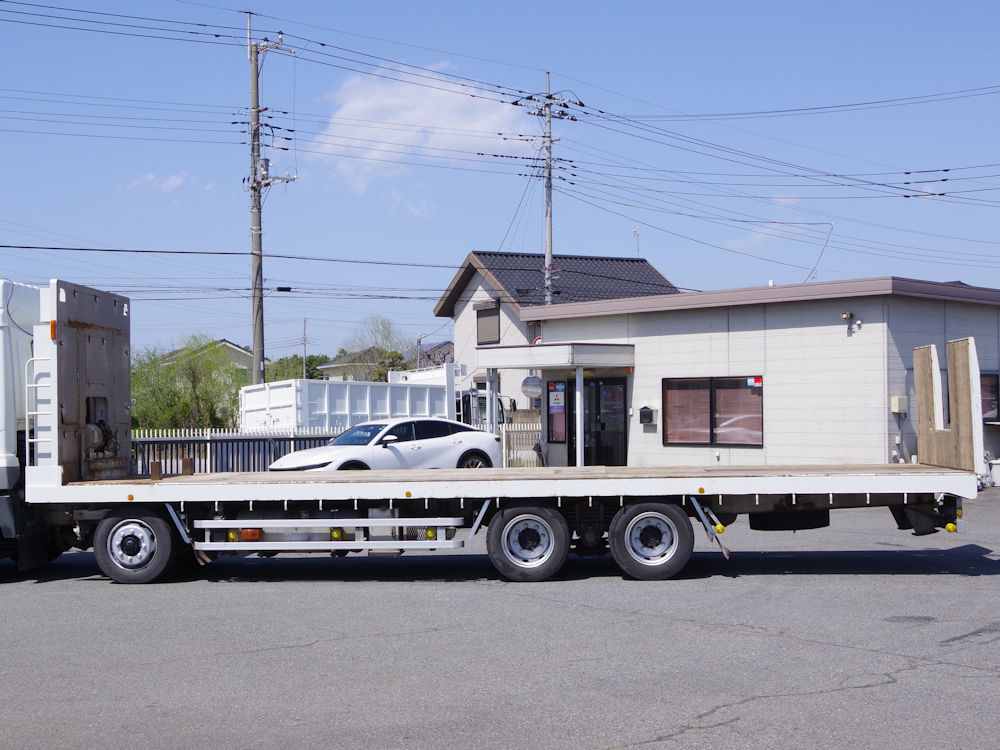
top-left (0, 280), bottom-right (983, 583)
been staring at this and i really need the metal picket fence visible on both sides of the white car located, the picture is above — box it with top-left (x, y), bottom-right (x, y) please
top-left (132, 423), bottom-right (541, 476)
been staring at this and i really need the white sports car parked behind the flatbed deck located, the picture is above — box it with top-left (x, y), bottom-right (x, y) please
top-left (270, 418), bottom-right (503, 471)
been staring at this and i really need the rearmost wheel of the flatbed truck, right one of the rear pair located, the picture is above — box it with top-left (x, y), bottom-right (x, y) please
top-left (608, 503), bottom-right (694, 581)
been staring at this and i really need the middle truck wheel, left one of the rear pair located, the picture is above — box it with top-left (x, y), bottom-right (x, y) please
top-left (486, 507), bottom-right (569, 581)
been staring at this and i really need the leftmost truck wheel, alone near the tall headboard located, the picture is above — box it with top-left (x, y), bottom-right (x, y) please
top-left (94, 508), bottom-right (174, 583)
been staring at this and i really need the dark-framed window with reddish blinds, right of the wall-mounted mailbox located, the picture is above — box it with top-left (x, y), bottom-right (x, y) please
top-left (663, 376), bottom-right (764, 446)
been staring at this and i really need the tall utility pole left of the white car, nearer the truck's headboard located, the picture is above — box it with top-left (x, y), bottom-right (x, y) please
top-left (247, 11), bottom-right (295, 385)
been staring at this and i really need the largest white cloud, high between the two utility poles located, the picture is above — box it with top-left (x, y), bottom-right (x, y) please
top-left (316, 67), bottom-right (527, 194)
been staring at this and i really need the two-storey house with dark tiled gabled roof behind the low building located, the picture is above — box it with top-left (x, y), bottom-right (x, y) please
top-left (434, 251), bottom-right (678, 418)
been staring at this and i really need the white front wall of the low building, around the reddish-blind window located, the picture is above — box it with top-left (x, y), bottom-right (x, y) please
top-left (543, 298), bottom-right (888, 465)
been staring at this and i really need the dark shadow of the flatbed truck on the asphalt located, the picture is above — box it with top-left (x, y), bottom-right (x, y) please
top-left (0, 544), bottom-right (1000, 584)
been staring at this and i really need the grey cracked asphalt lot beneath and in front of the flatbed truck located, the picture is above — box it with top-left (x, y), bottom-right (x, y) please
top-left (0, 490), bottom-right (1000, 750)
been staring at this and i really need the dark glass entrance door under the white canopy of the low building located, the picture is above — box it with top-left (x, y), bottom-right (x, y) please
top-left (566, 378), bottom-right (628, 466)
